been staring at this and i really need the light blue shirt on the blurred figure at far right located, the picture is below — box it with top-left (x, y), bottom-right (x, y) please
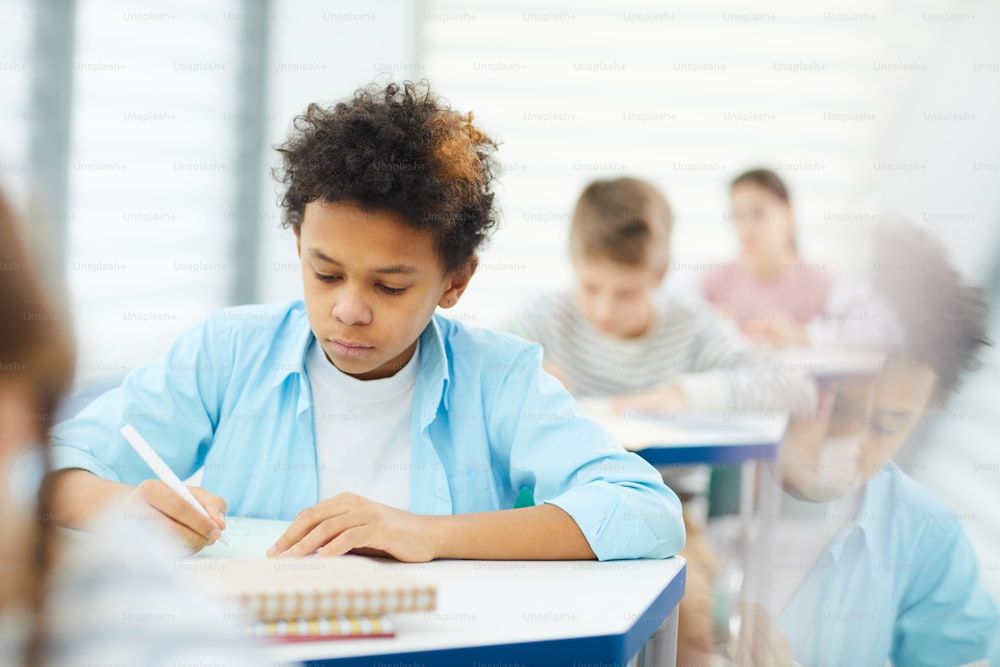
top-left (779, 462), bottom-right (1000, 667)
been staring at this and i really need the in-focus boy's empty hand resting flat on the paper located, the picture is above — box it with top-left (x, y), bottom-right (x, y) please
top-left (267, 493), bottom-right (436, 563)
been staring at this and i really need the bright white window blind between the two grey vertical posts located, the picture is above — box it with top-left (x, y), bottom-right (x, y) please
top-left (67, 0), bottom-right (241, 381)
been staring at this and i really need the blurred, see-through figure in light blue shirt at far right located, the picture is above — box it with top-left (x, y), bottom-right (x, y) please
top-left (728, 225), bottom-right (1000, 667)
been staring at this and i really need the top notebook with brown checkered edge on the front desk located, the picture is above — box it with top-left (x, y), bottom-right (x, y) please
top-left (180, 556), bottom-right (437, 621)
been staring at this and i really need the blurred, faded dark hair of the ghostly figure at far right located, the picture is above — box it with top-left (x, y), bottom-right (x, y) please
top-left (872, 220), bottom-right (991, 405)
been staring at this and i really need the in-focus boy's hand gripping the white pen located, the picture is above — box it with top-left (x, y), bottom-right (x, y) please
top-left (126, 479), bottom-right (226, 551)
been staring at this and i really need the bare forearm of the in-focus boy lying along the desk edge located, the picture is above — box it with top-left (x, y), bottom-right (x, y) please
top-left (427, 504), bottom-right (596, 560)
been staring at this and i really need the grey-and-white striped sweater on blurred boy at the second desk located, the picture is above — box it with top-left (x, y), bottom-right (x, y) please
top-left (507, 290), bottom-right (816, 414)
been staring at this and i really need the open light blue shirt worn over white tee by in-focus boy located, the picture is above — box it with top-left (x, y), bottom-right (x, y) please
top-left (52, 301), bottom-right (684, 560)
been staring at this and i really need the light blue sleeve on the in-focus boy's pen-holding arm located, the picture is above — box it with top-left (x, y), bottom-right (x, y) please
top-left (52, 318), bottom-right (230, 484)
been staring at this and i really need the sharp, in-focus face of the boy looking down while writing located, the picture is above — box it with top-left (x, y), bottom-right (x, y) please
top-left (296, 201), bottom-right (475, 380)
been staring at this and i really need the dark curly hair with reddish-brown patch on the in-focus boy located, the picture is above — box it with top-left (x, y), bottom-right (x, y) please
top-left (275, 81), bottom-right (497, 272)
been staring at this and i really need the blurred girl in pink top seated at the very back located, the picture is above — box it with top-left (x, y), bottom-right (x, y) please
top-left (699, 169), bottom-right (891, 347)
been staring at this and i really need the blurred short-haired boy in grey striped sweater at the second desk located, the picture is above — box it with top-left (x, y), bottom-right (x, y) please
top-left (509, 178), bottom-right (814, 664)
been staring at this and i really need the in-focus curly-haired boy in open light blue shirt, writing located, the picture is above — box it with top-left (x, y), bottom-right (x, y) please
top-left (43, 82), bottom-right (684, 561)
